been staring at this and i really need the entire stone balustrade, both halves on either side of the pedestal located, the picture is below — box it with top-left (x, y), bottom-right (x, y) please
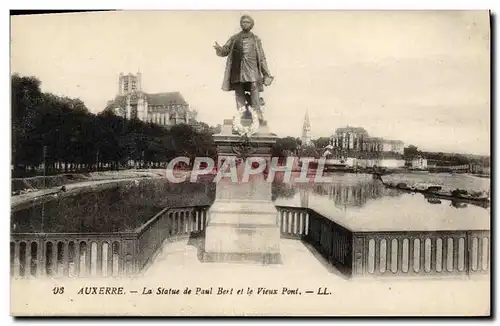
top-left (10, 206), bottom-right (491, 278)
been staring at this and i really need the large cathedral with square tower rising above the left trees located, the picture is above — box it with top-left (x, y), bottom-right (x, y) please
top-left (106, 72), bottom-right (192, 127)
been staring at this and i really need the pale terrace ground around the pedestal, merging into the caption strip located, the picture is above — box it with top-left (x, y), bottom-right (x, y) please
top-left (11, 238), bottom-right (490, 316)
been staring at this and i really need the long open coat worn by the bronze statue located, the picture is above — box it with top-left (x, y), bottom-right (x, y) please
top-left (217, 32), bottom-right (271, 92)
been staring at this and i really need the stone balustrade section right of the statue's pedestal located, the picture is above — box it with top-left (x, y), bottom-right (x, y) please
top-left (277, 206), bottom-right (491, 277)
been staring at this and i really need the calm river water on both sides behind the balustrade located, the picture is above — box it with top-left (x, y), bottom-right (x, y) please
top-left (11, 173), bottom-right (490, 233)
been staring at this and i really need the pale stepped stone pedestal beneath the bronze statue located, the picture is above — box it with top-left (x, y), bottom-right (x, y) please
top-left (203, 120), bottom-right (281, 264)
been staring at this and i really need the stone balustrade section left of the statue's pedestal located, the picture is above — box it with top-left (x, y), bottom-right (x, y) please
top-left (10, 206), bottom-right (208, 278)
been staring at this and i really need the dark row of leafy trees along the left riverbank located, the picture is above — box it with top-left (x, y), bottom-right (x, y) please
top-left (11, 75), bottom-right (215, 176)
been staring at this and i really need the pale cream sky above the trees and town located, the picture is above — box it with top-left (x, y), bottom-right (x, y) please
top-left (11, 11), bottom-right (490, 155)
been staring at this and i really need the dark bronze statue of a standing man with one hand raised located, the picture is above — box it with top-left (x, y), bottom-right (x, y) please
top-left (214, 15), bottom-right (274, 120)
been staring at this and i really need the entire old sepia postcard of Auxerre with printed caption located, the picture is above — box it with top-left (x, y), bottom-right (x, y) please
top-left (10, 11), bottom-right (492, 316)
